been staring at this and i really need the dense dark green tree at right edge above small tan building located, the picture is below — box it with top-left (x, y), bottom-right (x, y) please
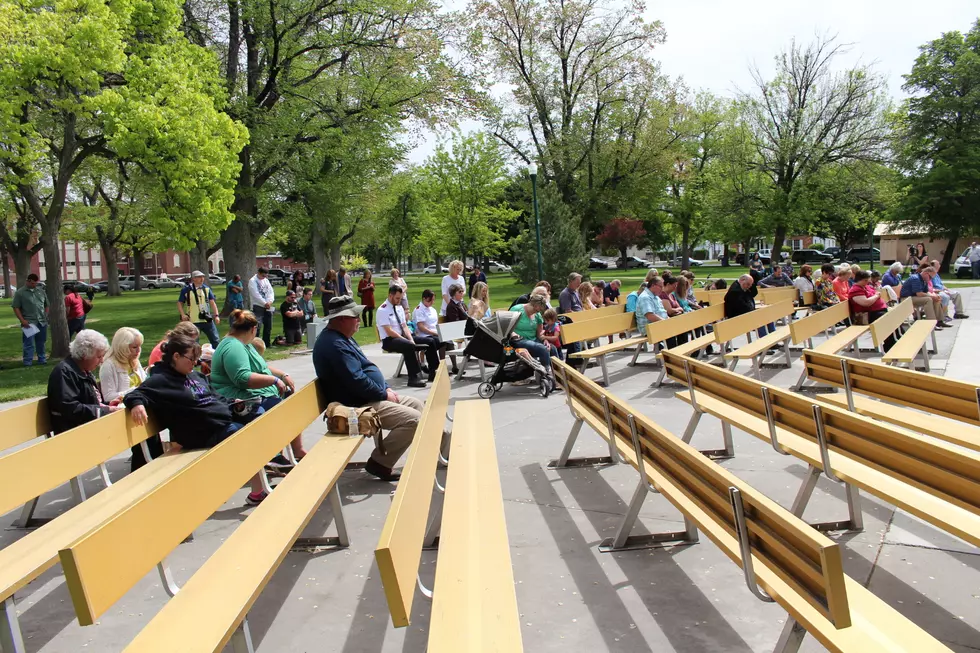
top-left (897, 20), bottom-right (980, 271)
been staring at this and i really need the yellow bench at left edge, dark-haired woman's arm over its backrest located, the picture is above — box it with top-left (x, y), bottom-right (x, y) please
top-left (0, 411), bottom-right (198, 653)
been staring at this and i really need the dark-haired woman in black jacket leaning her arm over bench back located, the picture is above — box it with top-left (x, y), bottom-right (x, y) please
top-left (123, 332), bottom-right (266, 505)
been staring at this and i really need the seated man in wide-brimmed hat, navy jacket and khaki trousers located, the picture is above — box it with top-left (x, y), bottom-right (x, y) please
top-left (313, 296), bottom-right (448, 481)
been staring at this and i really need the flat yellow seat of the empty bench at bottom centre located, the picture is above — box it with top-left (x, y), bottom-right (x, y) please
top-left (428, 400), bottom-right (523, 653)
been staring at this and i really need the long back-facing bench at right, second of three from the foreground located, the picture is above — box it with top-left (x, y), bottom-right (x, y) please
top-left (667, 352), bottom-right (980, 546)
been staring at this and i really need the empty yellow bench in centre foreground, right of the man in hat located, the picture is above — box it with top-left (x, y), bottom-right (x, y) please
top-left (375, 384), bottom-right (523, 652)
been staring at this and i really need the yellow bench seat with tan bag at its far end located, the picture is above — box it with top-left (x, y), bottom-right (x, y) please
top-left (125, 436), bottom-right (364, 653)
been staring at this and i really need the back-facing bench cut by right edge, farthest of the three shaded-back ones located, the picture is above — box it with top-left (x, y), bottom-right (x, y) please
top-left (803, 351), bottom-right (980, 451)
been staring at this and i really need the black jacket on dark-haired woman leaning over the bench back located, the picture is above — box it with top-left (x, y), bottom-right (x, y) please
top-left (123, 361), bottom-right (234, 449)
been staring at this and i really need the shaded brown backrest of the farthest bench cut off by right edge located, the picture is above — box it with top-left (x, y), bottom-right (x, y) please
top-left (803, 349), bottom-right (980, 426)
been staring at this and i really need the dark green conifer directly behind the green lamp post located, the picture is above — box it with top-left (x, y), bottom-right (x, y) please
top-left (514, 184), bottom-right (589, 288)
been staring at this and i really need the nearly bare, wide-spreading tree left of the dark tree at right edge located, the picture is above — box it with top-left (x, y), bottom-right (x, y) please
top-left (741, 37), bottom-right (889, 255)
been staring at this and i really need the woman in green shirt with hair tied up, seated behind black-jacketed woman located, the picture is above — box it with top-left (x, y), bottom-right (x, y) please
top-left (211, 309), bottom-right (306, 460)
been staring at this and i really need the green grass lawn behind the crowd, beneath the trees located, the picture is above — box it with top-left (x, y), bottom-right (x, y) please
top-left (0, 265), bottom-right (980, 402)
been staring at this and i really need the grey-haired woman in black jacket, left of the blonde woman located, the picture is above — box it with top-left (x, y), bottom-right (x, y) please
top-left (48, 329), bottom-right (119, 433)
